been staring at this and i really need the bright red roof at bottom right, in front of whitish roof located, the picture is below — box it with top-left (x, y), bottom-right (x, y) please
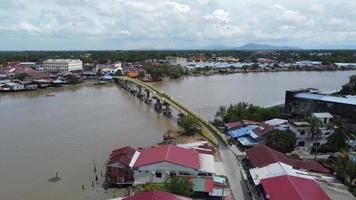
top-left (261, 175), bottom-right (330, 200)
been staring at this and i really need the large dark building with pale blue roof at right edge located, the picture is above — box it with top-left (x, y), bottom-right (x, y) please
top-left (284, 88), bottom-right (356, 124)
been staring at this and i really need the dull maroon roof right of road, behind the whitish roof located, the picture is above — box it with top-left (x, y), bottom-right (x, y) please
top-left (246, 144), bottom-right (330, 173)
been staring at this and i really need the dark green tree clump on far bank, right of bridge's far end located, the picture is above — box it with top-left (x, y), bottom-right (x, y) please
top-left (143, 63), bottom-right (187, 79)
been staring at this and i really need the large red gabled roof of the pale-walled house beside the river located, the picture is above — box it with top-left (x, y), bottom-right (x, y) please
top-left (134, 145), bottom-right (200, 170)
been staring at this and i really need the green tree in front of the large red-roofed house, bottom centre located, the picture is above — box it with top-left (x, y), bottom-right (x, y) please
top-left (164, 176), bottom-right (193, 197)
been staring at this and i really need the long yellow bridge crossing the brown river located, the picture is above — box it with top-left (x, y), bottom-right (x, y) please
top-left (115, 76), bottom-right (229, 146)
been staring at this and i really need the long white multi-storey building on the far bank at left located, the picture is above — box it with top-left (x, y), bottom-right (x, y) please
top-left (42, 59), bottom-right (83, 72)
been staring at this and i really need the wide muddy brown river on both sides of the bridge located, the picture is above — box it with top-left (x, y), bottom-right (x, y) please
top-left (0, 71), bottom-right (355, 200)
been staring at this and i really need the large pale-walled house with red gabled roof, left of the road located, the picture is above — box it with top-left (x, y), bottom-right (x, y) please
top-left (133, 145), bottom-right (215, 184)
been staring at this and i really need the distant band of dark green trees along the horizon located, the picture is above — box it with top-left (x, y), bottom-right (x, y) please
top-left (0, 50), bottom-right (356, 65)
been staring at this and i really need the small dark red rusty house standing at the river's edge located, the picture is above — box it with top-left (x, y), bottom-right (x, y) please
top-left (106, 147), bottom-right (140, 185)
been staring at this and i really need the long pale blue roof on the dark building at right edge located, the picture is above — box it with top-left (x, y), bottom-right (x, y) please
top-left (294, 92), bottom-right (356, 106)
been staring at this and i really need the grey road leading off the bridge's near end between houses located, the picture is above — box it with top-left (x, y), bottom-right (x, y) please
top-left (219, 142), bottom-right (251, 200)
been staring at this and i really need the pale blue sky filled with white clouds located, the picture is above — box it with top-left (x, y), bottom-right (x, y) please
top-left (0, 0), bottom-right (356, 50)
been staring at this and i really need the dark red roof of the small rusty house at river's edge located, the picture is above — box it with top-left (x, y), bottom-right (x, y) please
top-left (108, 147), bottom-right (136, 166)
